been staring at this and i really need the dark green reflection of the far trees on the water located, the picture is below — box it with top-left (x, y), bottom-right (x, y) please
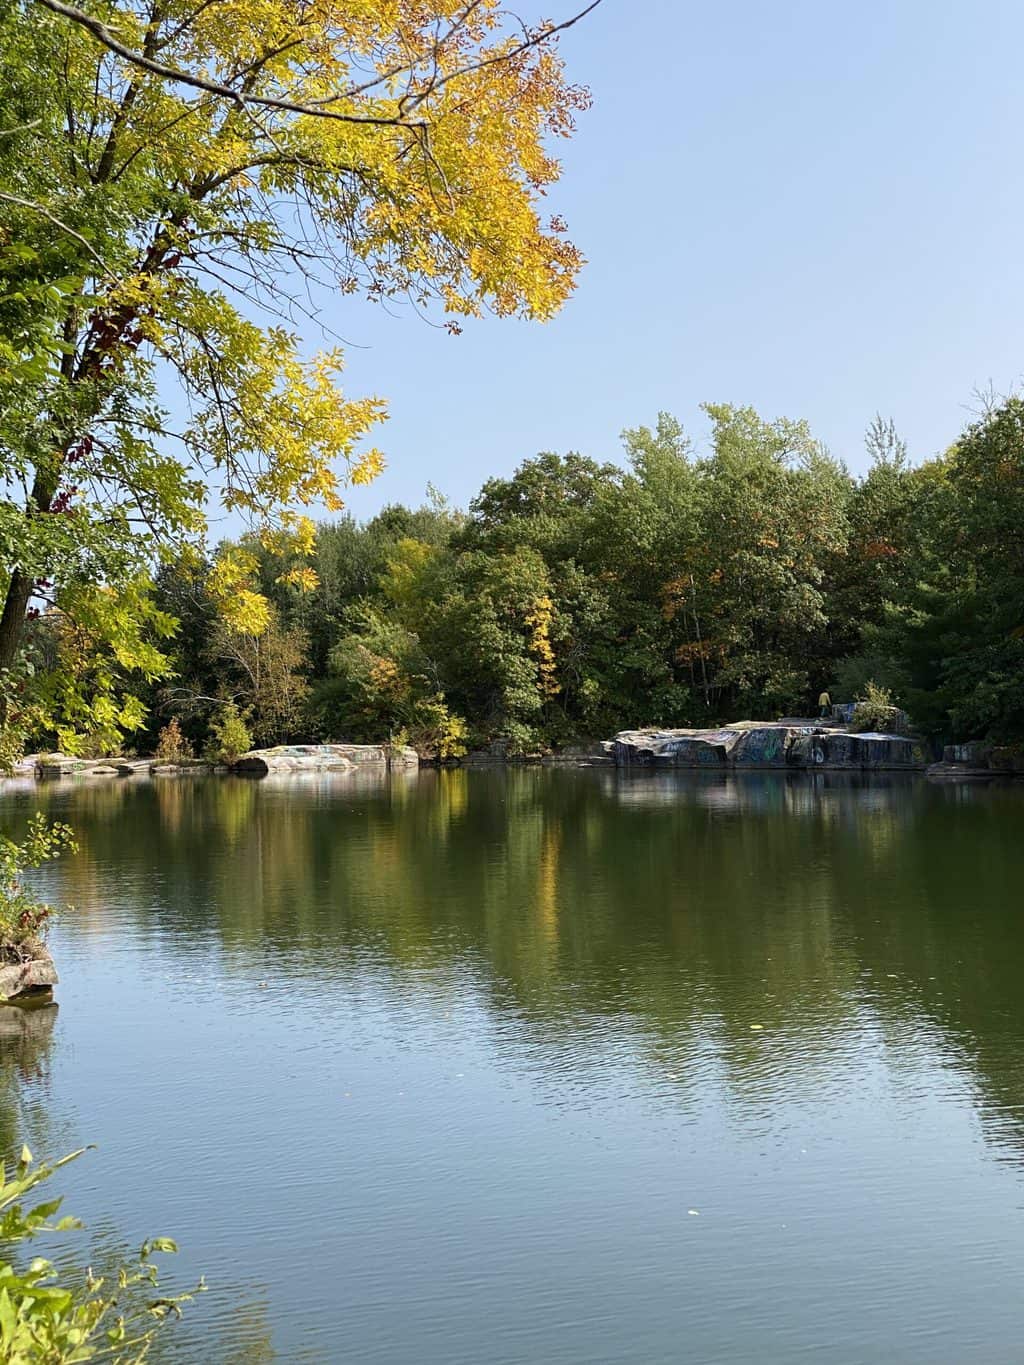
top-left (22, 770), bottom-right (1024, 1148)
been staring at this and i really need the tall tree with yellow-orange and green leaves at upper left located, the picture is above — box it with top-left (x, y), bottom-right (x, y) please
top-left (0, 0), bottom-right (593, 737)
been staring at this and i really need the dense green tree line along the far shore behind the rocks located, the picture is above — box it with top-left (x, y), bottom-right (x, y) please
top-left (30, 397), bottom-right (1024, 758)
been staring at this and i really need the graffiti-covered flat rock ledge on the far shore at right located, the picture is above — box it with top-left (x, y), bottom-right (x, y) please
top-left (613, 722), bottom-right (924, 771)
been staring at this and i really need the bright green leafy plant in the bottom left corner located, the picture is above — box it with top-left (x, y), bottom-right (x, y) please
top-left (0, 1148), bottom-right (202, 1365)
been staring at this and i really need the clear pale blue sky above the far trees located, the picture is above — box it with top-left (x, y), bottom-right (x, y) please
top-left (319, 0), bottom-right (1024, 517)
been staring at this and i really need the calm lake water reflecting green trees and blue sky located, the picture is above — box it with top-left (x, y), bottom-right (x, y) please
top-left (0, 770), bottom-right (1024, 1365)
